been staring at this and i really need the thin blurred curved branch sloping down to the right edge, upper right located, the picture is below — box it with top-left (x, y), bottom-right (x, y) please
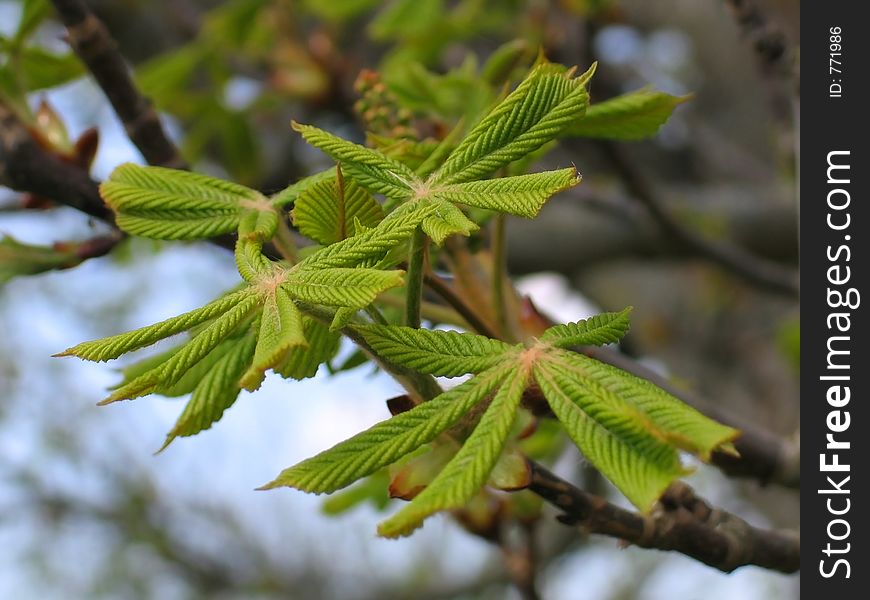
top-left (599, 141), bottom-right (800, 296)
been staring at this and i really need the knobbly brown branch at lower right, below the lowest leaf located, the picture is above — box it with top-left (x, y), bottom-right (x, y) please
top-left (529, 463), bottom-right (800, 573)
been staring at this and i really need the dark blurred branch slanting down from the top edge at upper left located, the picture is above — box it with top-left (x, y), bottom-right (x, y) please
top-left (52, 0), bottom-right (187, 169)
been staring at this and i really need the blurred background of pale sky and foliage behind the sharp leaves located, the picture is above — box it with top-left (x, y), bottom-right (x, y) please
top-left (0, 0), bottom-right (800, 600)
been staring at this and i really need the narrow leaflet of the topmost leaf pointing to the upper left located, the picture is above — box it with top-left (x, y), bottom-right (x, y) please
top-left (293, 121), bottom-right (419, 199)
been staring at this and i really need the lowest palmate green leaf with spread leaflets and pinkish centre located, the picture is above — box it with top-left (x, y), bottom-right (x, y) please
top-left (267, 309), bottom-right (738, 537)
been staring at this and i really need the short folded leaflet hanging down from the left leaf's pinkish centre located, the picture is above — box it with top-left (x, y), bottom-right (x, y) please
top-left (240, 287), bottom-right (307, 391)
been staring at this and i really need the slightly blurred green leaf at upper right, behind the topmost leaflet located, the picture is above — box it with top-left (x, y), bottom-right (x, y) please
top-left (562, 88), bottom-right (691, 140)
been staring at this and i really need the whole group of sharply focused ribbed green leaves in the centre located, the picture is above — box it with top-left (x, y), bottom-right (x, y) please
top-left (54, 62), bottom-right (736, 536)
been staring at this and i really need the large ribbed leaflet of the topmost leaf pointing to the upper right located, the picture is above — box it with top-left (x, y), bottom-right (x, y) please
top-left (433, 64), bottom-right (589, 185)
